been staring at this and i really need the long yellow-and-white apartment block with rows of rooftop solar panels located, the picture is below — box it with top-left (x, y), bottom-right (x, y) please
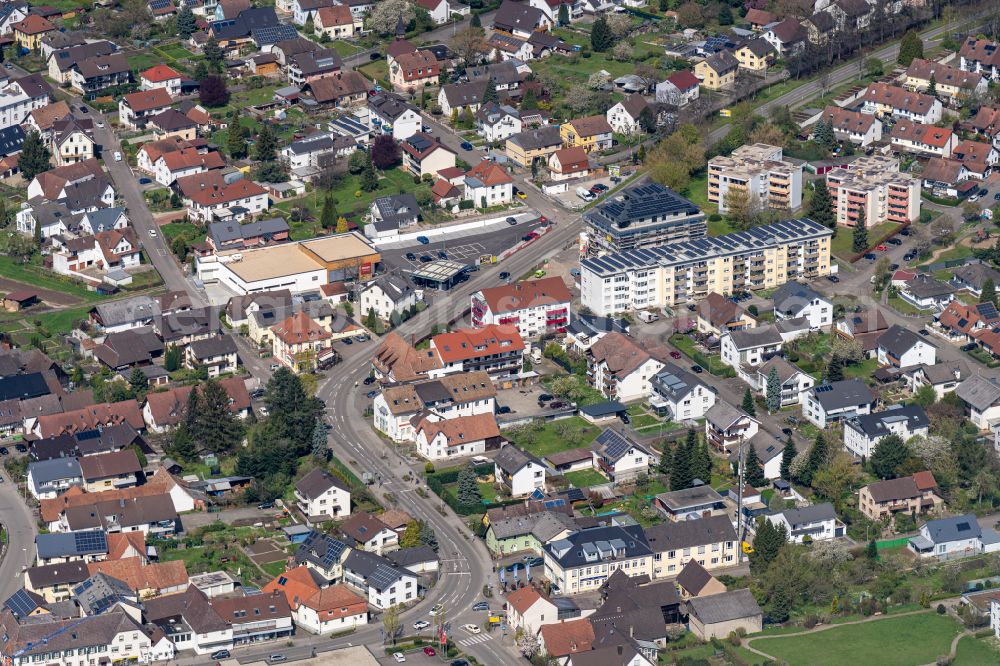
top-left (580, 218), bottom-right (833, 317)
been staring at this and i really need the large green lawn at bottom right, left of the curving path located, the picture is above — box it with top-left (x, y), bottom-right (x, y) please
top-left (752, 612), bottom-right (960, 666)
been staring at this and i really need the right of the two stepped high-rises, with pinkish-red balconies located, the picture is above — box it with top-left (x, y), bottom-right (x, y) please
top-left (826, 155), bottom-right (920, 227)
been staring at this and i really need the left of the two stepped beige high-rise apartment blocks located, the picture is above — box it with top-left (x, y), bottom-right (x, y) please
top-left (708, 143), bottom-right (802, 213)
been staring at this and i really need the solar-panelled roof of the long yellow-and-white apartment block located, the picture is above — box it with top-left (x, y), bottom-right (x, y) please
top-left (580, 217), bottom-right (833, 275)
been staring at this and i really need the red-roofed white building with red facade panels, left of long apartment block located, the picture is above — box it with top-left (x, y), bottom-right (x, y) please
top-left (470, 277), bottom-right (573, 338)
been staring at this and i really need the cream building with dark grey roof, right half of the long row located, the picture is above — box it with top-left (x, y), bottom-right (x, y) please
top-left (644, 515), bottom-right (740, 579)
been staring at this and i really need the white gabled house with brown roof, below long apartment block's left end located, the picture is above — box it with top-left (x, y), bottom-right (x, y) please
top-left (587, 333), bottom-right (669, 402)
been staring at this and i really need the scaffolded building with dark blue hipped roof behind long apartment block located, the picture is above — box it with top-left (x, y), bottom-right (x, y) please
top-left (583, 183), bottom-right (707, 255)
